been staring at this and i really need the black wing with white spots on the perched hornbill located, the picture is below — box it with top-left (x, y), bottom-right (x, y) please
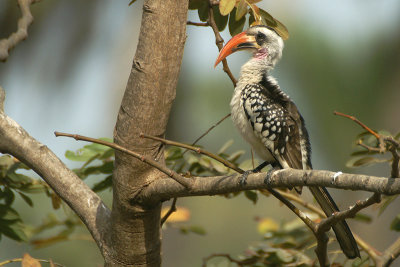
top-left (241, 84), bottom-right (309, 169)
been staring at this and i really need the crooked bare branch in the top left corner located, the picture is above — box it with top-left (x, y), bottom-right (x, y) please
top-left (0, 0), bottom-right (40, 61)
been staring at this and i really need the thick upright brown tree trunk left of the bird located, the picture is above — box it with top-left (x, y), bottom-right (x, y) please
top-left (103, 0), bottom-right (188, 266)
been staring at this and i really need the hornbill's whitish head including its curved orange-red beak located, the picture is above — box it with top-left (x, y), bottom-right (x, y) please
top-left (214, 25), bottom-right (283, 67)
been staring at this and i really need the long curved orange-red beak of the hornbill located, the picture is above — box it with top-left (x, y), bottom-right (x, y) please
top-left (214, 32), bottom-right (256, 68)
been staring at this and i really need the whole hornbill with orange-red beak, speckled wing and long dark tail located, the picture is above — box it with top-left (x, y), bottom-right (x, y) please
top-left (214, 25), bottom-right (360, 259)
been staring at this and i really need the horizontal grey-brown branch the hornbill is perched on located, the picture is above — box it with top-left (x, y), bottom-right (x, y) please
top-left (140, 169), bottom-right (400, 204)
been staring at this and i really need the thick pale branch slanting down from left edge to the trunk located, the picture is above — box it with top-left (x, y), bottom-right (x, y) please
top-left (0, 90), bottom-right (110, 252)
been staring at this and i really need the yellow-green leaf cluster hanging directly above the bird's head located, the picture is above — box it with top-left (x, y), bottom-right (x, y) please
top-left (189, 0), bottom-right (289, 40)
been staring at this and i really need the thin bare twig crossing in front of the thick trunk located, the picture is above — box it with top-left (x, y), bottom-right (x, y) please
top-left (54, 132), bottom-right (191, 191)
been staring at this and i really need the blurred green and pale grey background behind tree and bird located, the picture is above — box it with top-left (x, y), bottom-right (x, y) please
top-left (0, 0), bottom-right (400, 267)
